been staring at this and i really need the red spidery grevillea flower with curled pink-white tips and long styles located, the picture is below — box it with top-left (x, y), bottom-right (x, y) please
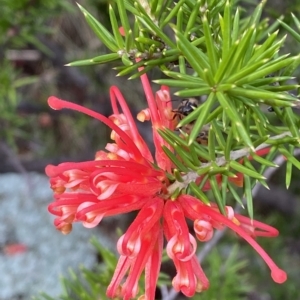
top-left (46, 75), bottom-right (286, 300)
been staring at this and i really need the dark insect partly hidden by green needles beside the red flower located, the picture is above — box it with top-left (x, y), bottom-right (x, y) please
top-left (173, 98), bottom-right (209, 145)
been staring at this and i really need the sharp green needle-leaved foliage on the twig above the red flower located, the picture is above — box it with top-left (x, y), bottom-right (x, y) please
top-left (69, 0), bottom-right (300, 216)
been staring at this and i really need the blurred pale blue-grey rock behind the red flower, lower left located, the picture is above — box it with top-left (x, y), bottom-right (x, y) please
top-left (0, 173), bottom-right (99, 300)
